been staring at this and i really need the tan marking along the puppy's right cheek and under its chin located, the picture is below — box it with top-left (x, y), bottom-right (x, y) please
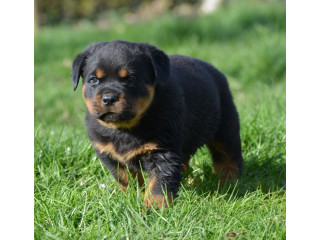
top-left (98, 85), bottom-right (154, 129)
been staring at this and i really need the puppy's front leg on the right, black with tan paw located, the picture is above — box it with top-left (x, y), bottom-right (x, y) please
top-left (144, 152), bottom-right (182, 208)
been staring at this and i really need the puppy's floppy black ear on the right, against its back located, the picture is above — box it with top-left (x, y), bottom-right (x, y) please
top-left (144, 44), bottom-right (170, 84)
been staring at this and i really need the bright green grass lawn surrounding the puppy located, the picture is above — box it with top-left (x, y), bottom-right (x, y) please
top-left (34, 2), bottom-right (286, 239)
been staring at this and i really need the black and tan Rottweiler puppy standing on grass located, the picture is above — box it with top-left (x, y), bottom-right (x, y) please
top-left (72, 41), bottom-right (243, 207)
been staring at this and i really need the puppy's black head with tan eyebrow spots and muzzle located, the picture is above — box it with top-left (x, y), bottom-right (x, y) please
top-left (72, 41), bottom-right (170, 128)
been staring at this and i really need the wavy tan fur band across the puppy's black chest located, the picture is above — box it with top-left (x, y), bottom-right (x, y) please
top-left (93, 142), bottom-right (158, 163)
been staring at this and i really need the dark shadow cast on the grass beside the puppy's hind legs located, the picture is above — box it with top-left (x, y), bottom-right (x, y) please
top-left (183, 153), bottom-right (286, 197)
